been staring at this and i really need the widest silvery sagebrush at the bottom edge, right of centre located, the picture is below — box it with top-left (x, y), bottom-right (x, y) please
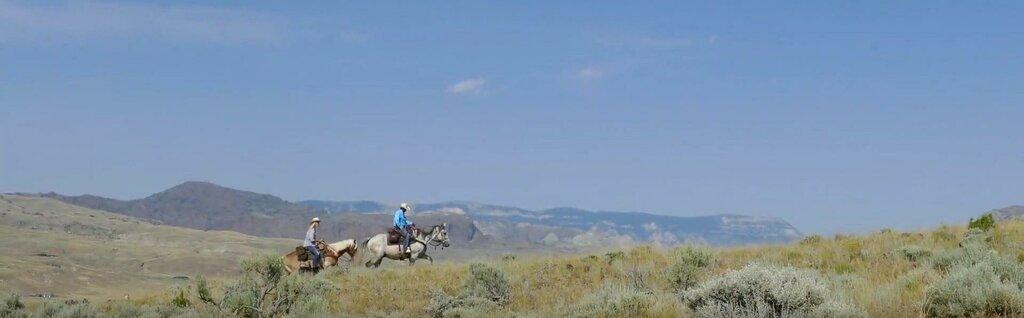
top-left (683, 264), bottom-right (866, 317)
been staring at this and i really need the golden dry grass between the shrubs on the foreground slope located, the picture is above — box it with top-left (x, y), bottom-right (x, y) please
top-left (315, 222), bottom-right (1024, 317)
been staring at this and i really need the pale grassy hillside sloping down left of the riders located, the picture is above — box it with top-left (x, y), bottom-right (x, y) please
top-left (0, 194), bottom-right (300, 299)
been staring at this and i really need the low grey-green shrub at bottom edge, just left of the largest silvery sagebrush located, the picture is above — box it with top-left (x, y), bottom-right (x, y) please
top-left (564, 285), bottom-right (655, 317)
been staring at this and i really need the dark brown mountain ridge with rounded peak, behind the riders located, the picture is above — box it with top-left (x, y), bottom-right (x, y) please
top-left (30, 181), bottom-right (477, 243)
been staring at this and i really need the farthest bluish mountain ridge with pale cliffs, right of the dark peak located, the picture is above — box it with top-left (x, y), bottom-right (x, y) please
top-left (300, 200), bottom-right (803, 245)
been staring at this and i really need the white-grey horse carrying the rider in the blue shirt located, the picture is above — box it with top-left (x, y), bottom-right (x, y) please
top-left (358, 223), bottom-right (451, 268)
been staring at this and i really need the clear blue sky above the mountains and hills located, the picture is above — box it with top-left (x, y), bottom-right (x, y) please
top-left (0, 0), bottom-right (1024, 233)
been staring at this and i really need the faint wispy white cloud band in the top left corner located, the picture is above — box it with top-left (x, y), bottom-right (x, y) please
top-left (0, 0), bottom-right (287, 44)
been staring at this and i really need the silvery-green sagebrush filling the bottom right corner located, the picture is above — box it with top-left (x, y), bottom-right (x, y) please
top-left (925, 262), bottom-right (1024, 317)
